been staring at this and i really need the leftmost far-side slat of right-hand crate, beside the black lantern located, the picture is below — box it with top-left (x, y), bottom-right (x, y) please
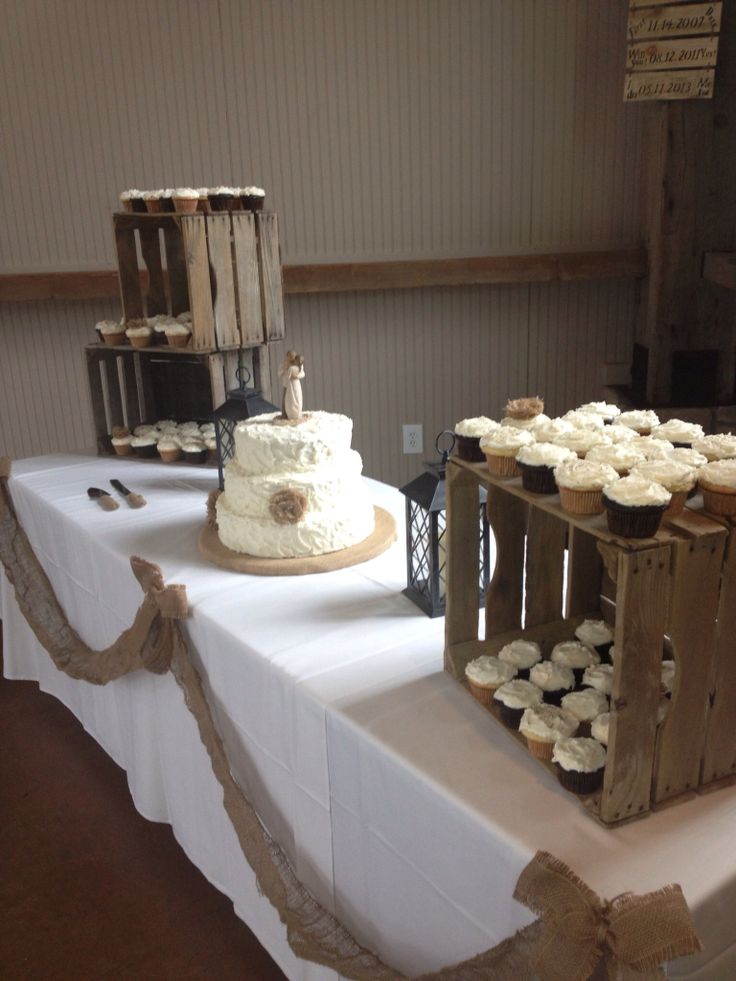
top-left (484, 485), bottom-right (527, 637)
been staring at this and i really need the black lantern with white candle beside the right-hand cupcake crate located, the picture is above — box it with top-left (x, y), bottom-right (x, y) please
top-left (401, 429), bottom-right (490, 617)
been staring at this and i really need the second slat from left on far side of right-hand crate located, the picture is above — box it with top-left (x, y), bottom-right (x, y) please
top-left (524, 507), bottom-right (564, 627)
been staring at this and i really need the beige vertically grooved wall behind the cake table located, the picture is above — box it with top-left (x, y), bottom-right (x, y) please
top-left (0, 0), bottom-right (640, 482)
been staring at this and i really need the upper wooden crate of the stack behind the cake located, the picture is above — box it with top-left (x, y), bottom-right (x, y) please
top-left (113, 211), bottom-right (284, 352)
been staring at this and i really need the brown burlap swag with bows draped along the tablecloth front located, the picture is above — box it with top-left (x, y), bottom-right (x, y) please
top-left (0, 457), bottom-right (700, 981)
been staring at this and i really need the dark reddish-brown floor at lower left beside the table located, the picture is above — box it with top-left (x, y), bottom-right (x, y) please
top-left (0, 628), bottom-right (284, 981)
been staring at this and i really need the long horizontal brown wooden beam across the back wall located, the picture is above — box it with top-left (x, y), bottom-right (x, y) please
top-left (0, 249), bottom-right (647, 303)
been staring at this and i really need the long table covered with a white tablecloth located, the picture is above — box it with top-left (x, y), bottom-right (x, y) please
top-left (0, 454), bottom-right (736, 981)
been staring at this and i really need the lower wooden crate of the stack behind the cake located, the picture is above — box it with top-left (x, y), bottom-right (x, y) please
top-left (85, 344), bottom-right (239, 454)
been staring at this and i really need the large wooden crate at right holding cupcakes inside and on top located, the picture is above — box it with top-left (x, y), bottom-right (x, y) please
top-left (445, 459), bottom-right (736, 825)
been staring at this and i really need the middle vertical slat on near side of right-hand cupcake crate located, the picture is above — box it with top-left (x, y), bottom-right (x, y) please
top-left (653, 529), bottom-right (726, 803)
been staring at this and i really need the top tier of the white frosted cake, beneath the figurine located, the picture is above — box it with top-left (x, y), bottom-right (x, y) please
top-left (235, 412), bottom-right (353, 475)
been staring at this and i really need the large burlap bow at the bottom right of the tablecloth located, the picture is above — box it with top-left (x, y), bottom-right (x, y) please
top-left (514, 852), bottom-right (702, 981)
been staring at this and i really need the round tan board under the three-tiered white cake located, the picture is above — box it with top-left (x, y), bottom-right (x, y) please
top-left (197, 508), bottom-right (396, 576)
